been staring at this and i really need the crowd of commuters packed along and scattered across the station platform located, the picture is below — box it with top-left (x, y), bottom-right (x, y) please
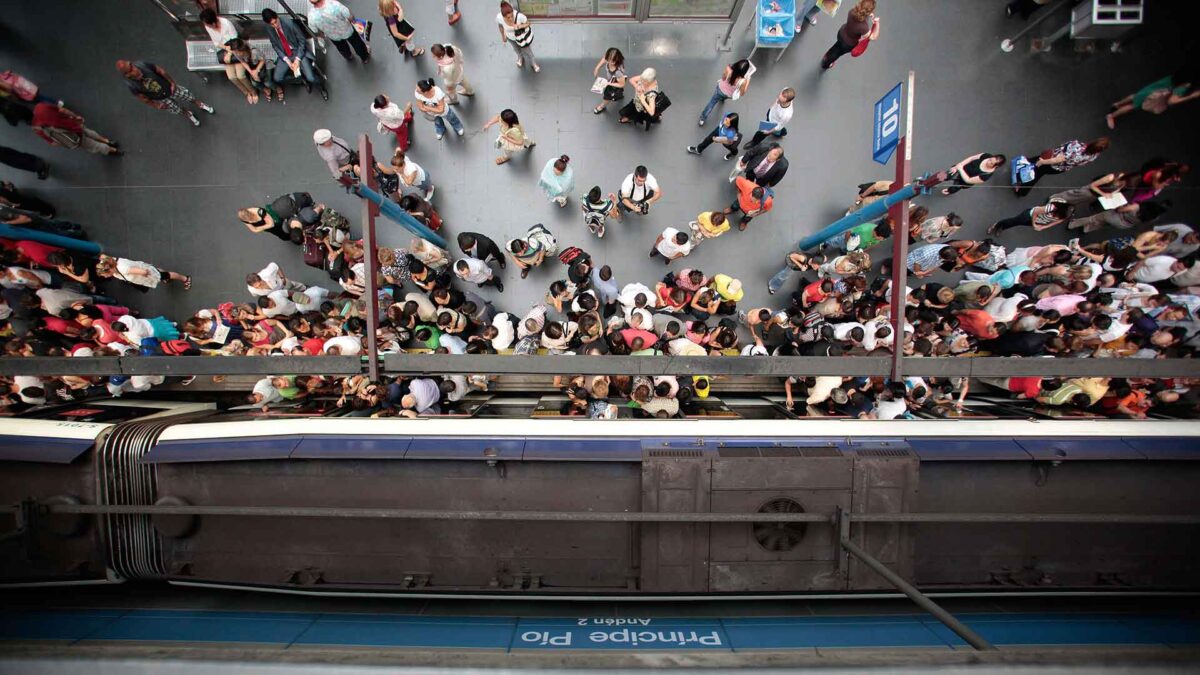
top-left (0, 0), bottom-right (1200, 419)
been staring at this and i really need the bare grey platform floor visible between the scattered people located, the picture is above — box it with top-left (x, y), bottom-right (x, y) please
top-left (0, 0), bottom-right (1200, 321)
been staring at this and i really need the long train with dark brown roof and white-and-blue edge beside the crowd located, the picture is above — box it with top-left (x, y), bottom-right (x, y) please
top-left (0, 395), bottom-right (1200, 598)
